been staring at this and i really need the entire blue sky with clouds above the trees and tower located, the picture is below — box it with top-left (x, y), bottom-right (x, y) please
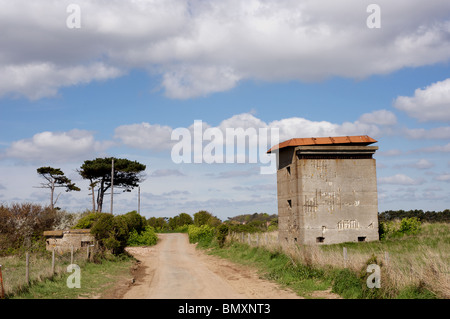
top-left (0, 0), bottom-right (450, 219)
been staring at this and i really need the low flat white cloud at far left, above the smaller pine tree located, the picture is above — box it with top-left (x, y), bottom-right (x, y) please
top-left (5, 130), bottom-right (111, 162)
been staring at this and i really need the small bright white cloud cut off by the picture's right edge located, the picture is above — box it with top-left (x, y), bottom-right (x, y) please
top-left (394, 79), bottom-right (450, 122)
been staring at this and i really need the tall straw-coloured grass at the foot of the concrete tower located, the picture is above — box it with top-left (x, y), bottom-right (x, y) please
top-left (223, 223), bottom-right (450, 298)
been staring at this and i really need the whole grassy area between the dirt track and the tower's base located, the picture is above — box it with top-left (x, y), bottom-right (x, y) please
top-left (198, 223), bottom-right (450, 299)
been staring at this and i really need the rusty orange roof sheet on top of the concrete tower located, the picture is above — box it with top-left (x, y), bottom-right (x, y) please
top-left (267, 135), bottom-right (377, 153)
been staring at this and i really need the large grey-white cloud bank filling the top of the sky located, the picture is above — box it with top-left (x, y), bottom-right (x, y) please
top-left (0, 0), bottom-right (450, 99)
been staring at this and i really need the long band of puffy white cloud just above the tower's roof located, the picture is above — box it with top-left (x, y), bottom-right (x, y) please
top-left (114, 110), bottom-right (395, 155)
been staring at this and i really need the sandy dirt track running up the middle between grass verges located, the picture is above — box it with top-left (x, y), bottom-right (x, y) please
top-left (123, 233), bottom-right (301, 299)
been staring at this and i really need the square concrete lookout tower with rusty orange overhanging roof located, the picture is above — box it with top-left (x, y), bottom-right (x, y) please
top-left (268, 136), bottom-right (379, 244)
